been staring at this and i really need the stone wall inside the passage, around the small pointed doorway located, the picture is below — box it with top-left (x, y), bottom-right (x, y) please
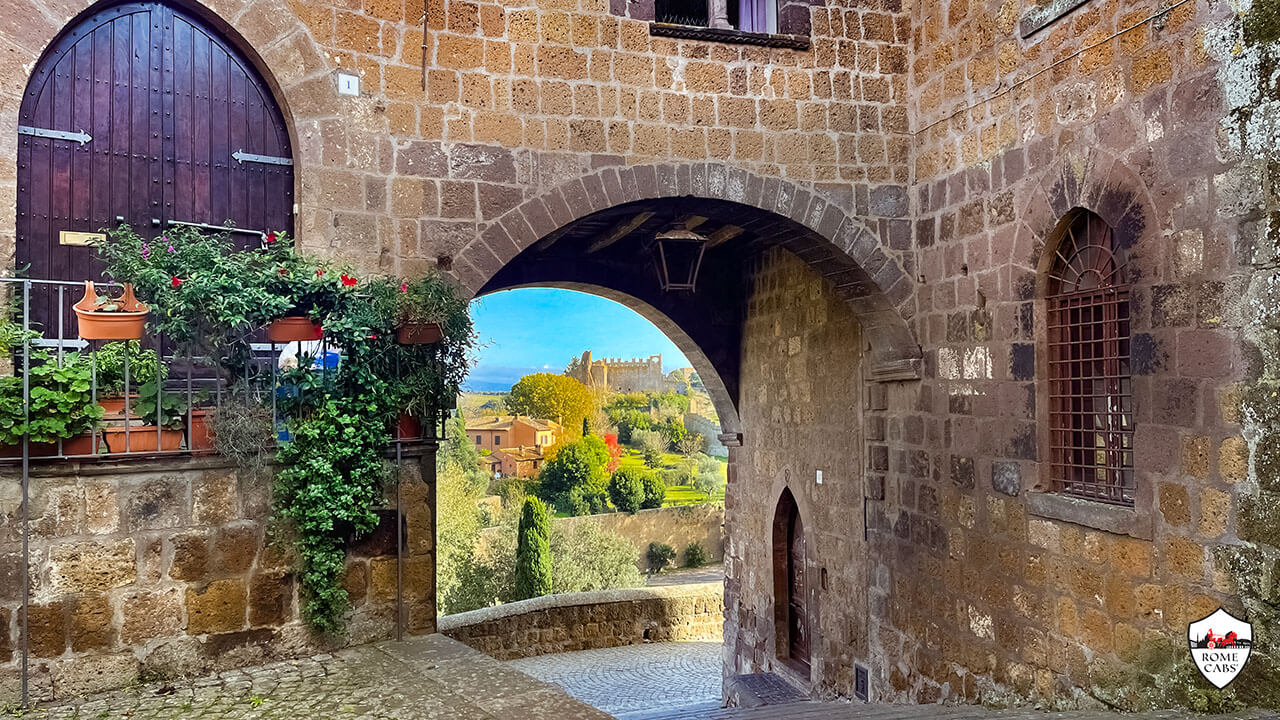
top-left (724, 245), bottom-right (872, 697)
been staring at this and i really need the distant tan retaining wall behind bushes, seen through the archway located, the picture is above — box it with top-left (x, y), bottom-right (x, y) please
top-left (554, 503), bottom-right (724, 573)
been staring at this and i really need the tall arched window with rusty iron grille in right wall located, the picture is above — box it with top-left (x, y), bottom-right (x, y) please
top-left (1046, 210), bottom-right (1134, 506)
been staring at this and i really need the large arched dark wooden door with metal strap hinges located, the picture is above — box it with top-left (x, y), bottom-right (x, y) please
top-left (15, 3), bottom-right (293, 334)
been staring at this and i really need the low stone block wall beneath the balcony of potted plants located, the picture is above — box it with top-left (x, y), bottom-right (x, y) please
top-left (0, 457), bottom-right (435, 706)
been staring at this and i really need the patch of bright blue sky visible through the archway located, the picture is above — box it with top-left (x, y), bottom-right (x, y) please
top-left (466, 288), bottom-right (689, 391)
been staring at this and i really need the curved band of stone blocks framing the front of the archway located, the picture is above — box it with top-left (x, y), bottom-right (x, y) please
top-left (453, 164), bottom-right (920, 380)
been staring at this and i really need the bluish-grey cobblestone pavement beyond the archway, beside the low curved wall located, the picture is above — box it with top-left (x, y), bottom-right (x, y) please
top-left (507, 642), bottom-right (721, 715)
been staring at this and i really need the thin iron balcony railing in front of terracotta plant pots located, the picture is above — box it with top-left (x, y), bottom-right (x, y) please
top-left (0, 278), bottom-right (421, 465)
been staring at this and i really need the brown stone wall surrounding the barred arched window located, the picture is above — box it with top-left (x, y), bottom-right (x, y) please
top-left (849, 0), bottom-right (1280, 708)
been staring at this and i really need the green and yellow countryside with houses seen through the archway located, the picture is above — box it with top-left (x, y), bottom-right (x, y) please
top-left (436, 340), bottom-right (728, 614)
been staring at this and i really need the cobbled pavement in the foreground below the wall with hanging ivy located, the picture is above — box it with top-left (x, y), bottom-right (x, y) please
top-left (8, 635), bottom-right (609, 720)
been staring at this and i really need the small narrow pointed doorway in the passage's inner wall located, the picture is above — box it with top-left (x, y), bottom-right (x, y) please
top-left (773, 488), bottom-right (813, 678)
